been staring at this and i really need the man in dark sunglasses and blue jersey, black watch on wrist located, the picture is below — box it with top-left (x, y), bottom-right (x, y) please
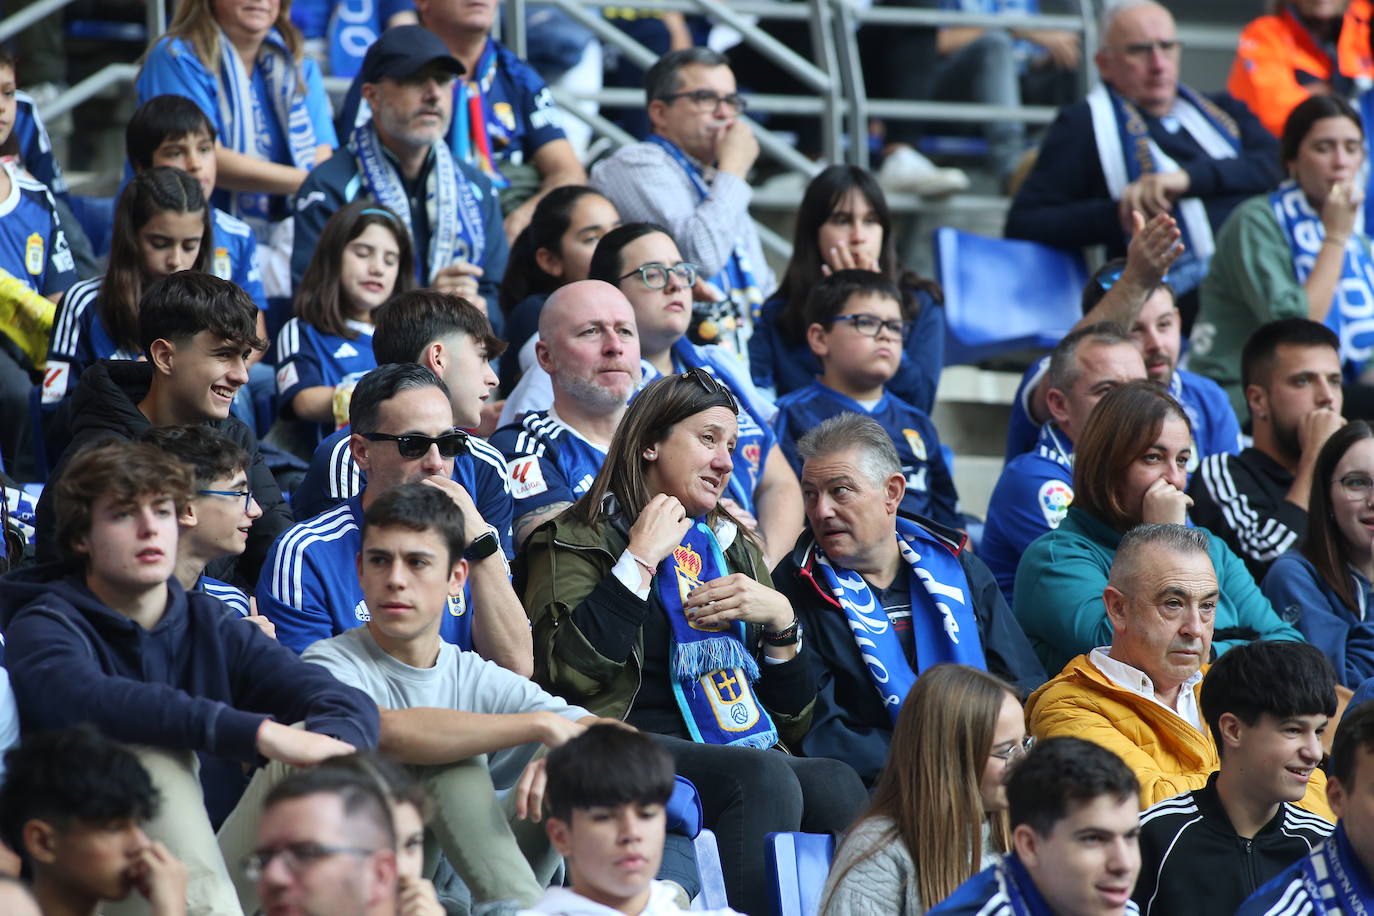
top-left (257, 363), bottom-right (534, 676)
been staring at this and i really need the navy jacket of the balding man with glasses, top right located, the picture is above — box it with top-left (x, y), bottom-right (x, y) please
top-left (1006, 92), bottom-right (1283, 255)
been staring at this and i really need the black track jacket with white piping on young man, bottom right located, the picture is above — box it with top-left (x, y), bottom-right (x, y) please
top-left (1132, 773), bottom-right (1336, 916)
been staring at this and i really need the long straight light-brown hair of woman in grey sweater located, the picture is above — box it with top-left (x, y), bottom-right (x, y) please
top-left (820, 665), bottom-right (1015, 912)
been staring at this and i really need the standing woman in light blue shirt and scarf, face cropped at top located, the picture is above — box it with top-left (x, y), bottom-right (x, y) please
top-left (135, 0), bottom-right (338, 230)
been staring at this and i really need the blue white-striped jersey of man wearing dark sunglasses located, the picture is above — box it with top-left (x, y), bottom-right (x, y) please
top-left (256, 496), bottom-right (473, 654)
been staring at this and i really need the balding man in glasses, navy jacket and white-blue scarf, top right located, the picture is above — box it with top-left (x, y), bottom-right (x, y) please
top-left (1006, 0), bottom-right (1282, 295)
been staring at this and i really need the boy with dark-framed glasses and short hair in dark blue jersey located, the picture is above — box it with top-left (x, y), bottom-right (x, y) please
top-left (774, 271), bottom-right (963, 529)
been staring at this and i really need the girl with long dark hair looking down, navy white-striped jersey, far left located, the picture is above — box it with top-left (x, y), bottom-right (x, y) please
top-left (43, 168), bottom-right (212, 409)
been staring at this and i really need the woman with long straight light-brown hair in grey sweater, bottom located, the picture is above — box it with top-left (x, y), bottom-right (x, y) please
top-left (820, 665), bottom-right (1029, 916)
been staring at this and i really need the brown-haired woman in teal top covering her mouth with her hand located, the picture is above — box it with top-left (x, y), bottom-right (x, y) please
top-left (1013, 382), bottom-right (1303, 672)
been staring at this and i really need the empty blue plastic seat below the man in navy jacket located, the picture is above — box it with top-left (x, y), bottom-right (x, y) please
top-left (934, 227), bottom-right (1088, 365)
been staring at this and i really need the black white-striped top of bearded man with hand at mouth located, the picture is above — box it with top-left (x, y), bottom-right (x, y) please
top-left (1189, 448), bottom-right (1307, 582)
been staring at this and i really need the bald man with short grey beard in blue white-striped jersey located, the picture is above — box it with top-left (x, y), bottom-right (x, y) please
top-left (492, 280), bottom-right (642, 545)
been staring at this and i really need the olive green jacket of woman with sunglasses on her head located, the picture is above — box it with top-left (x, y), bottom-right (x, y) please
top-left (515, 512), bottom-right (816, 746)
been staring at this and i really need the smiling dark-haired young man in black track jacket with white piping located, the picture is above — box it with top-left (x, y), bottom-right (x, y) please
top-left (1135, 641), bottom-right (1336, 916)
